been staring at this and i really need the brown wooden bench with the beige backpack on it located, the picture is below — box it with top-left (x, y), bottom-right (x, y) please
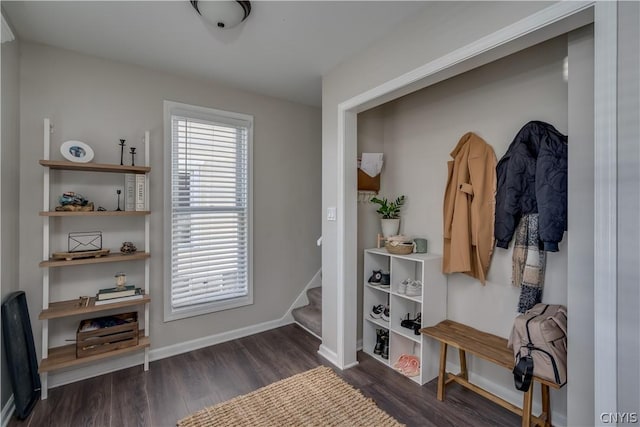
top-left (420, 320), bottom-right (560, 427)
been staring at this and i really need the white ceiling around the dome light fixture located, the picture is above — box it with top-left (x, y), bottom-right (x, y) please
top-left (2, 0), bottom-right (427, 106)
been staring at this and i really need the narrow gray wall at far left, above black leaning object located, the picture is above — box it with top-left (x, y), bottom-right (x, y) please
top-left (0, 35), bottom-right (20, 408)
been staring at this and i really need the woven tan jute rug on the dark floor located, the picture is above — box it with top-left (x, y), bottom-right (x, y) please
top-left (178, 366), bottom-right (402, 427)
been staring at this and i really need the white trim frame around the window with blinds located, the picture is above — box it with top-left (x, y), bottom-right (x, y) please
top-left (163, 100), bottom-right (253, 322)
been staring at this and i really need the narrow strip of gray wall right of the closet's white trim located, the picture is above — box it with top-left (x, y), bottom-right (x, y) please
top-left (618, 1), bottom-right (640, 414)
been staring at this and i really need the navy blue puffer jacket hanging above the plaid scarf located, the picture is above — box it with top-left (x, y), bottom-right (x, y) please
top-left (494, 121), bottom-right (568, 252)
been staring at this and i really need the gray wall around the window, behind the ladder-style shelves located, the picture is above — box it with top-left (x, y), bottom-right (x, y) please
top-left (20, 43), bottom-right (321, 384)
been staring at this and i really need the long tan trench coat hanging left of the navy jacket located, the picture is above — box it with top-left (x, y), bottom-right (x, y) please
top-left (442, 132), bottom-right (496, 284)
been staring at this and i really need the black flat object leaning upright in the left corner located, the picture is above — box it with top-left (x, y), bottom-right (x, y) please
top-left (2, 291), bottom-right (40, 420)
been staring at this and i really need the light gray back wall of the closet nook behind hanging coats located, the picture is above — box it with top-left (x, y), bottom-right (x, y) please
top-left (358, 36), bottom-right (572, 424)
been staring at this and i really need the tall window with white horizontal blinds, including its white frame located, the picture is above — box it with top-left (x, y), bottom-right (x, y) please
top-left (164, 101), bottom-right (253, 320)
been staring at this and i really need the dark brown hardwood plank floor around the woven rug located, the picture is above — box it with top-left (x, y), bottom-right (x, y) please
top-left (9, 325), bottom-right (520, 427)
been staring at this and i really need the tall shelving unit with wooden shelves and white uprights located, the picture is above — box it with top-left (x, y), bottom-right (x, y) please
top-left (39, 119), bottom-right (151, 399)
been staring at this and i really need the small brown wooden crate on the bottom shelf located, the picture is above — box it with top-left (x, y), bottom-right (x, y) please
top-left (76, 312), bottom-right (138, 357)
